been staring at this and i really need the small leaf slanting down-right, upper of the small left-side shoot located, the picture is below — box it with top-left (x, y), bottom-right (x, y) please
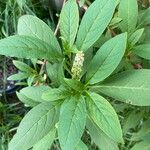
top-left (13, 60), bottom-right (36, 73)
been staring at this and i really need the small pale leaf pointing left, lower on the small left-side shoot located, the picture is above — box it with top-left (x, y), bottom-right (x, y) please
top-left (7, 72), bottom-right (30, 81)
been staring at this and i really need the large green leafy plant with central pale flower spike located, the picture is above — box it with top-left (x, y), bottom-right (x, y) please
top-left (0, 0), bottom-right (150, 150)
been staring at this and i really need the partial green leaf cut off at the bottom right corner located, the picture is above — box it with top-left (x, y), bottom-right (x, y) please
top-left (131, 141), bottom-right (150, 150)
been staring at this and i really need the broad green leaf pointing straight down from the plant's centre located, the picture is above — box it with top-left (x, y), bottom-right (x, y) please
top-left (58, 97), bottom-right (86, 150)
